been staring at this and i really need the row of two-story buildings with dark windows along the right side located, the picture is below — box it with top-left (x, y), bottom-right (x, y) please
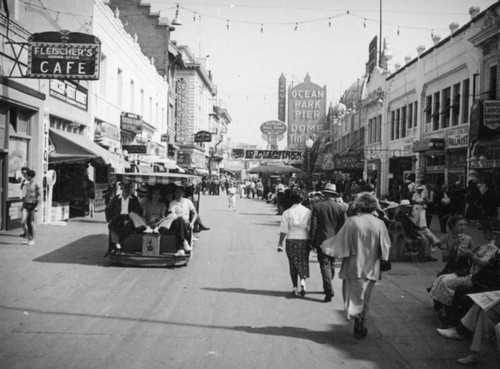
top-left (331, 3), bottom-right (500, 210)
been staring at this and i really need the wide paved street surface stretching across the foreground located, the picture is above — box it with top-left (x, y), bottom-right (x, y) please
top-left (0, 195), bottom-right (500, 369)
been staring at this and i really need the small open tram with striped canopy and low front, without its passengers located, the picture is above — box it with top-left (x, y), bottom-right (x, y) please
top-left (107, 173), bottom-right (201, 267)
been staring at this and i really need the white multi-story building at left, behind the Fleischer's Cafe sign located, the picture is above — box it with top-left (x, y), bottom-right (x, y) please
top-left (0, 0), bottom-right (169, 227)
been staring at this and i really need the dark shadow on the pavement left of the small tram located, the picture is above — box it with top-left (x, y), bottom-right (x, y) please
top-left (33, 234), bottom-right (108, 266)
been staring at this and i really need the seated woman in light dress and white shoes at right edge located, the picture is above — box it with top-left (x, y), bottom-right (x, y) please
top-left (429, 221), bottom-right (500, 324)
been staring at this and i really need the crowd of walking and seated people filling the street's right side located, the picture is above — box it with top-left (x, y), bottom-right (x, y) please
top-left (276, 175), bottom-right (500, 364)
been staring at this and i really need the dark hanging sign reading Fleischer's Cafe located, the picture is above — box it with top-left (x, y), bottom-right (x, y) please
top-left (26, 31), bottom-right (101, 80)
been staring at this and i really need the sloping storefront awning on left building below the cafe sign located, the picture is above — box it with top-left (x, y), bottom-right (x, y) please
top-left (49, 128), bottom-right (130, 171)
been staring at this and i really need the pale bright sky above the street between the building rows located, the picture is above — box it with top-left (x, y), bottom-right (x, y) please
top-left (150, 0), bottom-right (495, 149)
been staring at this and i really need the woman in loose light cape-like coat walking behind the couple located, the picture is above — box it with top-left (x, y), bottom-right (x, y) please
top-left (321, 193), bottom-right (391, 339)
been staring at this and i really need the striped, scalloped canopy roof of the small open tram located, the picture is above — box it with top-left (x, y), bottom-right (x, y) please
top-left (111, 173), bottom-right (201, 186)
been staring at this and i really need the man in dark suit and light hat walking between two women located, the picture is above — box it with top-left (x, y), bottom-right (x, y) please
top-left (309, 183), bottom-right (347, 302)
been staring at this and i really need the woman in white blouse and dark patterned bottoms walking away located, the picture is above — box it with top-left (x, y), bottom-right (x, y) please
top-left (278, 188), bottom-right (311, 296)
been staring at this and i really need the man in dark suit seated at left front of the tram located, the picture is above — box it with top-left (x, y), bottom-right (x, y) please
top-left (105, 183), bottom-right (142, 256)
